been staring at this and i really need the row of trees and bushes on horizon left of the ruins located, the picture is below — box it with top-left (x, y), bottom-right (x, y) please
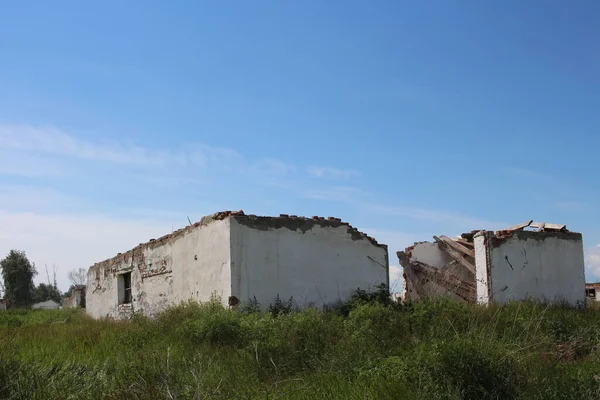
top-left (0, 250), bottom-right (87, 308)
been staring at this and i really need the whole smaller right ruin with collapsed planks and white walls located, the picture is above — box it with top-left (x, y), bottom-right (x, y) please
top-left (397, 221), bottom-right (591, 306)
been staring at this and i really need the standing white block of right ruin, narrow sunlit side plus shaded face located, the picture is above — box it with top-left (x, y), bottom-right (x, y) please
top-left (474, 230), bottom-right (585, 306)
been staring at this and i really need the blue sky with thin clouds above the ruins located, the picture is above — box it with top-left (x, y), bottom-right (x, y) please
top-left (0, 1), bottom-right (600, 289)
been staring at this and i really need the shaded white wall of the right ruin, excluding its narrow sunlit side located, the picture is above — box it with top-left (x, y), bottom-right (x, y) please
top-left (488, 232), bottom-right (585, 305)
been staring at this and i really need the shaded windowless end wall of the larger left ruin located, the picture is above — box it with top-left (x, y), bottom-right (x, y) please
top-left (231, 220), bottom-right (389, 307)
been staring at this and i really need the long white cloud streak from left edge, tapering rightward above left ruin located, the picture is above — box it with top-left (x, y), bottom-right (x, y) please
top-left (0, 125), bottom-right (359, 183)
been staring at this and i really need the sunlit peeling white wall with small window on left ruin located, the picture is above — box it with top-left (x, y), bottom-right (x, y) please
top-left (86, 219), bottom-right (231, 318)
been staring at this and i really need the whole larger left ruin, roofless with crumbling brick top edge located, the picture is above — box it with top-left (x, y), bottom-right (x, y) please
top-left (86, 211), bottom-right (389, 318)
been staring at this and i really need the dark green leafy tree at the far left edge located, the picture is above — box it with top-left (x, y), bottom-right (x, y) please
top-left (0, 250), bottom-right (37, 307)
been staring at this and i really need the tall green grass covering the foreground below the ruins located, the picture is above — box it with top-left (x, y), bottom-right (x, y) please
top-left (0, 295), bottom-right (600, 400)
